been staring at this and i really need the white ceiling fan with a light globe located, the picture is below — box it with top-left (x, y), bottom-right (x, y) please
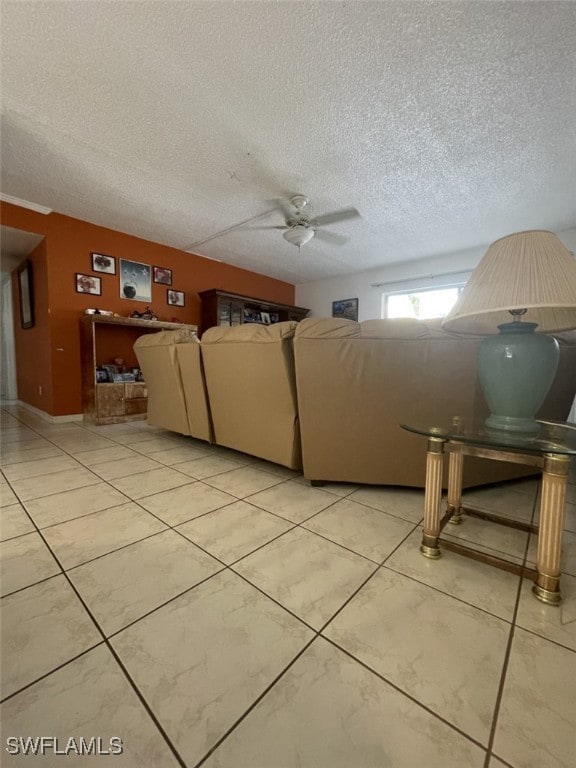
top-left (254, 195), bottom-right (360, 248)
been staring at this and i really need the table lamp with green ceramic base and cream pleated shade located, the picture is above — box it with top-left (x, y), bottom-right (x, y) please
top-left (442, 230), bottom-right (576, 434)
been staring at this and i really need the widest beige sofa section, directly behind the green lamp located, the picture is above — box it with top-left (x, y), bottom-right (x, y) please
top-left (294, 318), bottom-right (576, 487)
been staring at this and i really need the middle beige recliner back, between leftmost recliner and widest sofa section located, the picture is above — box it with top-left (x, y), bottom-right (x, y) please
top-left (202, 322), bottom-right (302, 469)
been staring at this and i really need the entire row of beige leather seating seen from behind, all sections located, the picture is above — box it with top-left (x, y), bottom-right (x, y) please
top-left (135, 318), bottom-right (576, 487)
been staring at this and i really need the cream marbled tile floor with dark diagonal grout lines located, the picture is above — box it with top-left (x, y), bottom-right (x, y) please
top-left (0, 406), bottom-right (576, 768)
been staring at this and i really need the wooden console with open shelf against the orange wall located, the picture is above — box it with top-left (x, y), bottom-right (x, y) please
top-left (80, 315), bottom-right (196, 426)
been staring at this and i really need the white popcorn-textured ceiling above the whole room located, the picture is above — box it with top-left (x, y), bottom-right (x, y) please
top-left (1, 0), bottom-right (576, 283)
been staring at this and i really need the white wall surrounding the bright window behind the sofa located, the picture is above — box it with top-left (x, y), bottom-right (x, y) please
top-left (295, 228), bottom-right (576, 321)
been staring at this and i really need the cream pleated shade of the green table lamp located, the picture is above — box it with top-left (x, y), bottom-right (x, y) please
top-left (442, 230), bottom-right (576, 335)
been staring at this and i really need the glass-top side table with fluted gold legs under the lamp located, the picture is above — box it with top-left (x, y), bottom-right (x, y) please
top-left (401, 417), bottom-right (576, 605)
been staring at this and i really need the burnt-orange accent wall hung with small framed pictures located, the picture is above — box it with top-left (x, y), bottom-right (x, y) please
top-left (0, 198), bottom-right (294, 416)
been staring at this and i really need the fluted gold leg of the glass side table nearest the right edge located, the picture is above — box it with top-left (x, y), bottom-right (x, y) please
top-left (532, 453), bottom-right (569, 605)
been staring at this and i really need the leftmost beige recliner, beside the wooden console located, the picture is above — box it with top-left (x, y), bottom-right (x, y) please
top-left (134, 328), bottom-right (212, 441)
